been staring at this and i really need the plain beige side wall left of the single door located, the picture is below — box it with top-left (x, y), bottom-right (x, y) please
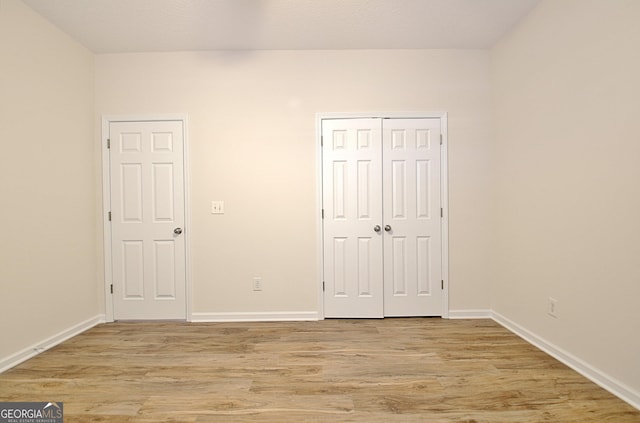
top-left (0, 0), bottom-right (99, 361)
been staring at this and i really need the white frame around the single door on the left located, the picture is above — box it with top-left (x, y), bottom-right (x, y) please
top-left (100, 114), bottom-right (193, 322)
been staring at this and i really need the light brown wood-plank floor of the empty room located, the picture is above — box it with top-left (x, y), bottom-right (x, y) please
top-left (0, 318), bottom-right (640, 423)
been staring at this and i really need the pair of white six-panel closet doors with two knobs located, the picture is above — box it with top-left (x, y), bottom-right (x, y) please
top-left (322, 118), bottom-right (443, 318)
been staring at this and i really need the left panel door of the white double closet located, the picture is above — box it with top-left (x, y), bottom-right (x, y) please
top-left (322, 119), bottom-right (383, 317)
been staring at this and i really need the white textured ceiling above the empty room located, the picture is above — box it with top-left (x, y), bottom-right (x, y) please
top-left (24, 0), bottom-right (539, 53)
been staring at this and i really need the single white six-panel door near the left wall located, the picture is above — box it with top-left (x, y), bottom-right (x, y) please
top-left (109, 121), bottom-right (186, 320)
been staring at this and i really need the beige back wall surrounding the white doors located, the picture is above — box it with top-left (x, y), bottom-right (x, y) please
top-left (96, 51), bottom-right (490, 313)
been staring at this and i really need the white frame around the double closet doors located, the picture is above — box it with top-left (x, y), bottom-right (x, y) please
top-left (316, 112), bottom-right (449, 319)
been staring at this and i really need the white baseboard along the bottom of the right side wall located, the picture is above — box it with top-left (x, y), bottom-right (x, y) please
top-left (491, 312), bottom-right (640, 410)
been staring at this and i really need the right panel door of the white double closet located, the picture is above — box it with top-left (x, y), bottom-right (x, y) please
top-left (382, 119), bottom-right (443, 316)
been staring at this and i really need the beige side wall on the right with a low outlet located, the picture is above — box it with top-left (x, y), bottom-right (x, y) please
top-left (491, 0), bottom-right (640, 392)
